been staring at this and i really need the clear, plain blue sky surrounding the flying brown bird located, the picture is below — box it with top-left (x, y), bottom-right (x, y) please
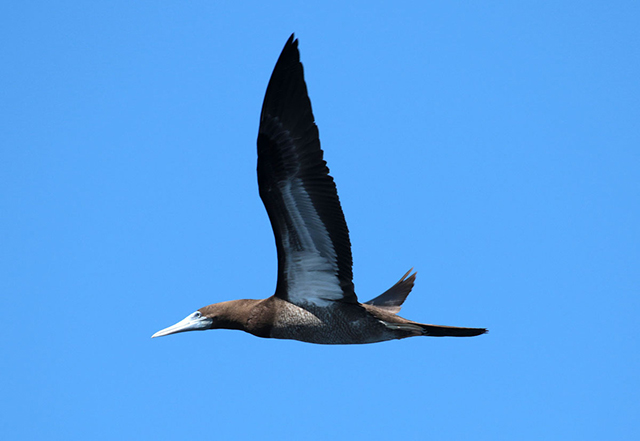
top-left (0, 1), bottom-right (640, 440)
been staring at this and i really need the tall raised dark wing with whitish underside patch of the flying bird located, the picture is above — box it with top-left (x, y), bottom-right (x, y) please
top-left (258, 35), bottom-right (358, 306)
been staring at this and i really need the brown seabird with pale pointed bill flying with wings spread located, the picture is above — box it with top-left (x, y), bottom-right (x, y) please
top-left (152, 34), bottom-right (487, 344)
